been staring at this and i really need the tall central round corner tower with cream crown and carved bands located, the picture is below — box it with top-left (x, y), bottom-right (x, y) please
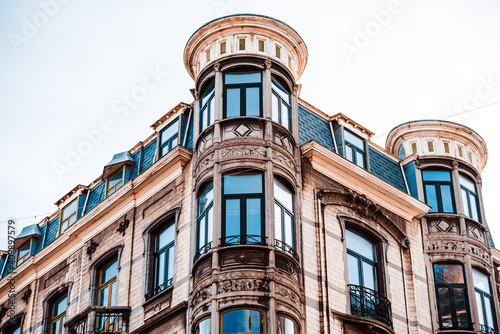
top-left (184, 14), bottom-right (307, 333)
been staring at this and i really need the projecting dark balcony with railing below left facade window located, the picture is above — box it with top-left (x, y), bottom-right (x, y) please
top-left (65, 306), bottom-right (130, 334)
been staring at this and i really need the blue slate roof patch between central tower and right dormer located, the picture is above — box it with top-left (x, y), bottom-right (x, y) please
top-left (299, 104), bottom-right (335, 151)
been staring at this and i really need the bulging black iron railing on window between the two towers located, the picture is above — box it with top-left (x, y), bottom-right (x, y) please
top-left (348, 284), bottom-right (392, 328)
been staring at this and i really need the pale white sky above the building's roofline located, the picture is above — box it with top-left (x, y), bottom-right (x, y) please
top-left (0, 0), bottom-right (500, 248)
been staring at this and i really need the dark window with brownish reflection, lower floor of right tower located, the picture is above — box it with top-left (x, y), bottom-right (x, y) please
top-left (434, 263), bottom-right (471, 329)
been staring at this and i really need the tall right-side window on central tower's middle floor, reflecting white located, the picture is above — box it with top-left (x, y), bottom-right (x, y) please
top-left (274, 178), bottom-right (297, 257)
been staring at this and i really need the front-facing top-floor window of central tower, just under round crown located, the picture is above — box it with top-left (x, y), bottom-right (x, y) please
top-left (223, 72), bottom-right (262, 118)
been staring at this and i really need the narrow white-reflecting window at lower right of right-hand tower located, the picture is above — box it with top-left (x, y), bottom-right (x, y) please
top-left (472, 268), bottom-right (497, 333)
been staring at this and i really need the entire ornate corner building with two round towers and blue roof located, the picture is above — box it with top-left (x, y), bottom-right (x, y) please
top-left (0, 14), bottom-right (500, 334)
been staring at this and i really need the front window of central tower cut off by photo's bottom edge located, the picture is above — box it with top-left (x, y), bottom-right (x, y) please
top-left (222, 310), bottom-right (264, 334)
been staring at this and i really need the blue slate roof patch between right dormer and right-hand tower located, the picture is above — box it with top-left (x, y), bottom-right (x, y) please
top-left (368, 146), bottom-right (406, 193)
